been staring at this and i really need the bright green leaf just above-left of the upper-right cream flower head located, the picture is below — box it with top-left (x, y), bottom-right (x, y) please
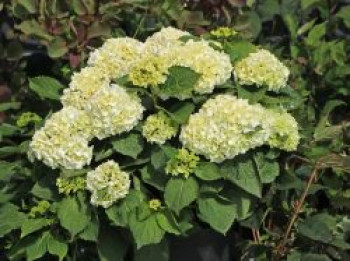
top-left (224, 41), bottom-right (256, 62)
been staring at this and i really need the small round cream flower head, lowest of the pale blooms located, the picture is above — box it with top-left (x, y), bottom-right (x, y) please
top-left (86, 160), bottom-right (130, 208)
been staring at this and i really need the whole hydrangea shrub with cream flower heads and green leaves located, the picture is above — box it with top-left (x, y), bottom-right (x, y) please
top-left (22, 27), bottom-right (300, 252)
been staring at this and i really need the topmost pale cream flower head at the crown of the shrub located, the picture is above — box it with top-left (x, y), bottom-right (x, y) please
top-left (145, 27), bottom-right (190, 55)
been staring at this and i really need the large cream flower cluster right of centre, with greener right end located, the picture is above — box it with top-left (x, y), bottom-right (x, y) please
top-left (180, 94), bottom-right (298, 162)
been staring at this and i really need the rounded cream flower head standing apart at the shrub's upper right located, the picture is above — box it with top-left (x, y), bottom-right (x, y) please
top-left (234, 49), bottom-right (289, 92)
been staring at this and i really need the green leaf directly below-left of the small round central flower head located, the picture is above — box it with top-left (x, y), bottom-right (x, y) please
top-left (112, 133), bottom-right (144, 159)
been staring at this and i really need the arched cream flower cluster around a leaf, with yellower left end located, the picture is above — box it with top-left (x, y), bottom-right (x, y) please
top-left (130, 28), bottom-right (232, 95)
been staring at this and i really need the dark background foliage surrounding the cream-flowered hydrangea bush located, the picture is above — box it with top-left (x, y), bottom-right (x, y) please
top-left (0, 0), bottom-right (350, 261)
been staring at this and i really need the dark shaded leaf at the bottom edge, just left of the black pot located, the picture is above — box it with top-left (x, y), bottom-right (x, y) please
top-left (134, 240), bottom-right (170, 261)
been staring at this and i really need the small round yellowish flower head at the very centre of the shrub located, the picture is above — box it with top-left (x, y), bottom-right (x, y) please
top-left (142, 112), bottom-right (177, 145)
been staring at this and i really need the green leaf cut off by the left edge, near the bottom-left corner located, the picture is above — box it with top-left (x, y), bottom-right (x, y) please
top-left (0, 203), bottom-right (27, 238)
